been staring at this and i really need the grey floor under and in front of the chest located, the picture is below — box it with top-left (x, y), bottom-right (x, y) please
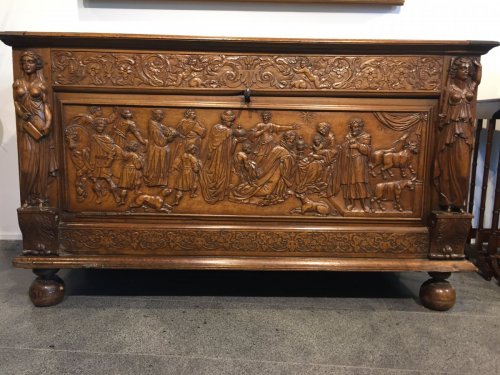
top-left (0, 241), bottom-right (500, 375)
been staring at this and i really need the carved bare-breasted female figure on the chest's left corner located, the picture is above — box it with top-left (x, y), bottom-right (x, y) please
top-left (13, 51), bottom-right (56, 207)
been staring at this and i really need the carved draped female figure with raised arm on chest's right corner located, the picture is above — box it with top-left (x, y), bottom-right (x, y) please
top-left (434, 57), bottom-right (481, 211)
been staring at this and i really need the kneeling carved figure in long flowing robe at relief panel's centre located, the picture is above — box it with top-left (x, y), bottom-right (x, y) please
top-left (229, 145), bottom-right (295, 205)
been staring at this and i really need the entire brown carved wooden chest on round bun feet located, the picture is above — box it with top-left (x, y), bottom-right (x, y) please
top-left (0, 32), bottom-right (497, 309)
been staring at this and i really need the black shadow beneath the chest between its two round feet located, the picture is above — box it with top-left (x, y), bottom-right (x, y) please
top-left (61, 269), bottom-right (415, 298)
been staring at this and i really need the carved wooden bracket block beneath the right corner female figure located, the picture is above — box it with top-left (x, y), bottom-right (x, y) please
top-left (429, 211), bottom-right (472, 259)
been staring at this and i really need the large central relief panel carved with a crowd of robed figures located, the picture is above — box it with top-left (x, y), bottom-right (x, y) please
top-left (60, 94), bottom-right (433, 218)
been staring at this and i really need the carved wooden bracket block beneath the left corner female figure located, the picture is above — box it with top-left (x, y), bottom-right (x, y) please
top-left (17, 207), bottom-right (59, 255)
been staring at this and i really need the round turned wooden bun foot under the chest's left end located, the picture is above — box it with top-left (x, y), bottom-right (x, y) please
top-left (29, 269), bottom-right (64, 307)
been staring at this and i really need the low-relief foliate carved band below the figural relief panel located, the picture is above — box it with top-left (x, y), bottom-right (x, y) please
top-left (57, 228), bottom-right (429, 256)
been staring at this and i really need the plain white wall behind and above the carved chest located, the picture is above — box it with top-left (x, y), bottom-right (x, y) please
top-left (0, 0), bottom-right (500, 239)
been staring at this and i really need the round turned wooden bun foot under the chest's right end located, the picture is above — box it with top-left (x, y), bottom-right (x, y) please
top-left (420, 272), bottom-right (457, 311)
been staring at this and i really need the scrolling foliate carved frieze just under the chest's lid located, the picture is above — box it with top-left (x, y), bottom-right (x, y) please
top-left (52, 50), bottom-right (443, 92)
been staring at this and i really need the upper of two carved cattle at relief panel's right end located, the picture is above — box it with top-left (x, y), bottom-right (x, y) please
top-left (369, 141), bottom-right (418, 180)
